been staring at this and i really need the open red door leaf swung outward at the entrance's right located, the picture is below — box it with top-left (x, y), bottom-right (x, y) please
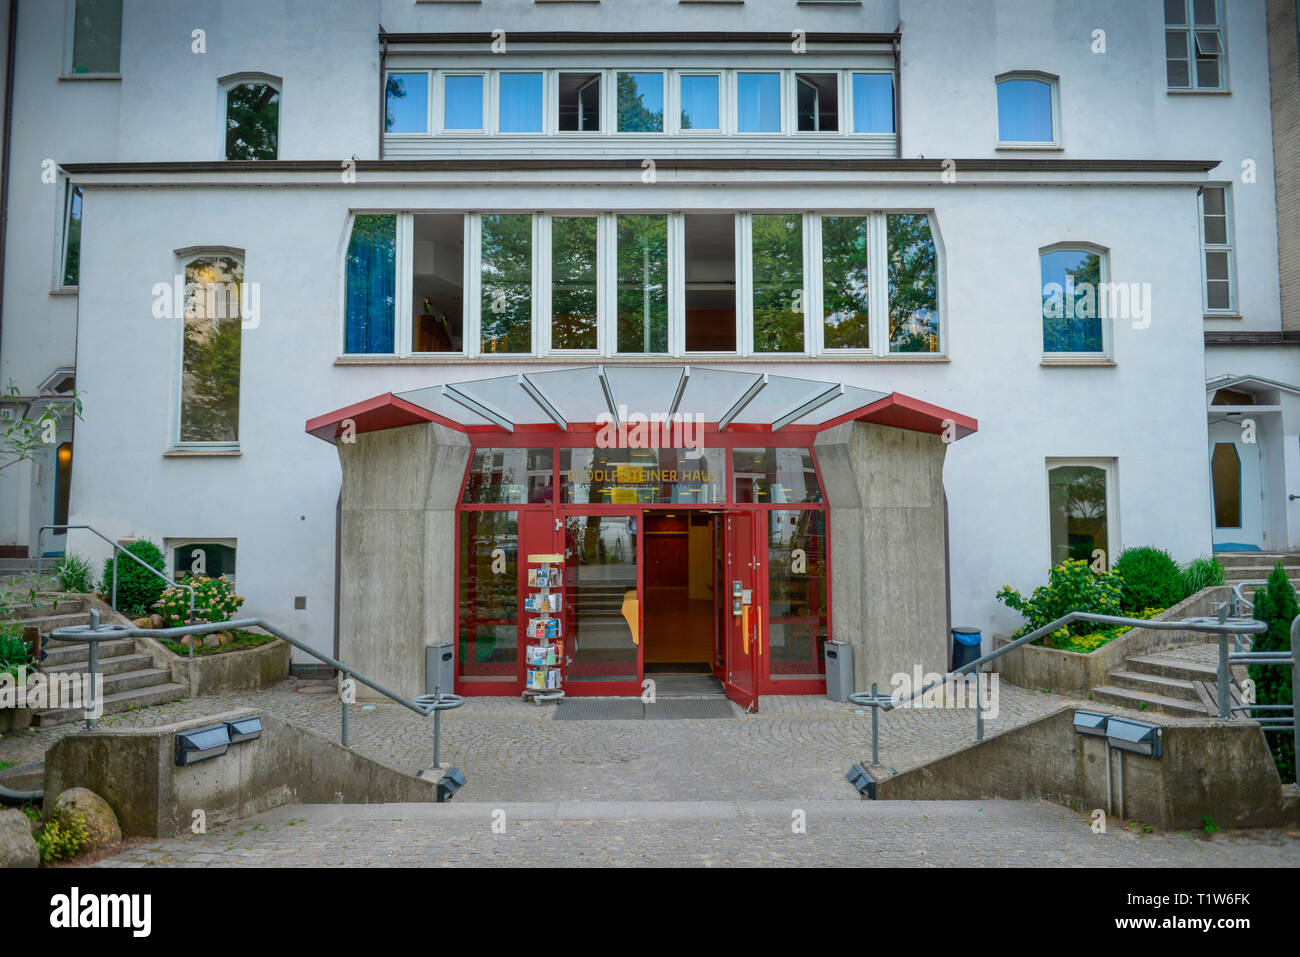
top-left (723, 510), bottom-right (763, 711)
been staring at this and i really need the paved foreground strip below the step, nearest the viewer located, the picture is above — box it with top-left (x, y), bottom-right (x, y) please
top-left (96, 800), bottom-right (1300, 867)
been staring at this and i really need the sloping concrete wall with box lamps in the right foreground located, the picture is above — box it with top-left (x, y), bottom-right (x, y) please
top-left (876, 707), bottom-right (1300, 828)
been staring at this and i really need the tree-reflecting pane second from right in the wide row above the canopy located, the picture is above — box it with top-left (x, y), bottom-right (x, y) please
top-left (822, 216), bottom-right (871, 348)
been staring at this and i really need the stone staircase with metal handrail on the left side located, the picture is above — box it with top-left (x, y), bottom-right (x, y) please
top-left (3, 597), bottom-right (189, 727)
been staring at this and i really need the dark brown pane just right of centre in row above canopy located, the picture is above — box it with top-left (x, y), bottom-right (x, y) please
top-left (683, 213), bottom-right (736, 352)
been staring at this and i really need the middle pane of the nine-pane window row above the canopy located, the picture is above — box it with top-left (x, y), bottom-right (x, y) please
top-left (615, 215), bottom-right (668, 352)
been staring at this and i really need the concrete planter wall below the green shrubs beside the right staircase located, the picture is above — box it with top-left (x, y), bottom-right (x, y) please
top-left (993, 585), bottom-right (1232, 698)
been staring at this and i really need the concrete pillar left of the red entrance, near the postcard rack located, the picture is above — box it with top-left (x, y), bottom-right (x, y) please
top-left (338, 423), bottom-right (469, 700)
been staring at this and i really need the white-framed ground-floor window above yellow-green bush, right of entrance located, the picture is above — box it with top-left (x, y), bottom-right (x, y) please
top-left (1047, 459), bottom-right (1119, 568)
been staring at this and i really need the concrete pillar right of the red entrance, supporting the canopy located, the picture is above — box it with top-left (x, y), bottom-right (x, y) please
top-left (815, 423), bottom-right (948, 692)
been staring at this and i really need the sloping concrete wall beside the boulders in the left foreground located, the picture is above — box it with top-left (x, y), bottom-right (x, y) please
top-left (44, 709), bottom-right (437, 837)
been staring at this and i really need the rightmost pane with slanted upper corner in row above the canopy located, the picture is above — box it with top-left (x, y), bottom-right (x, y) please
top-left (885, 213), bottom-right (939, 352)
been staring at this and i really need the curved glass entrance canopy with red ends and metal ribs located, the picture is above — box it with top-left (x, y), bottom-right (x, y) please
top-left (307, 365), bottom-right (979, 442)
